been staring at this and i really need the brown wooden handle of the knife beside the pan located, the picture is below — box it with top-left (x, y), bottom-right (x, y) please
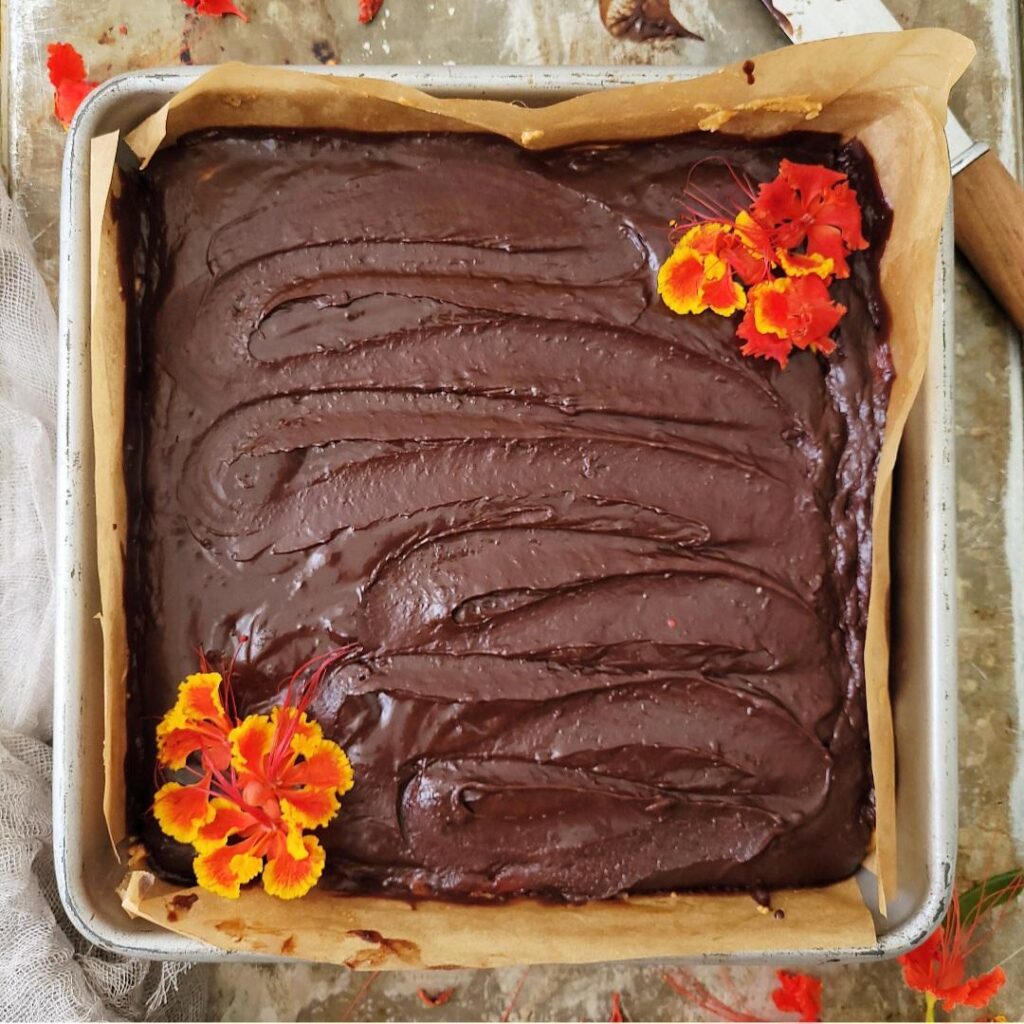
top-left (953, 151), bottom-right (1024, 332)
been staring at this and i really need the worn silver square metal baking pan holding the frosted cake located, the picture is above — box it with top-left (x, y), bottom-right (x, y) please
top-left (53, 67), bottom-right (957, 964)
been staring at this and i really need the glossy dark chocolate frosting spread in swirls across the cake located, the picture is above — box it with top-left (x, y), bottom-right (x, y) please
top-left (119, 125), bottom-right (891, 899)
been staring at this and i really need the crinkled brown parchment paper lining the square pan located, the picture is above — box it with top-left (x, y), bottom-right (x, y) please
top-left (90, 30), bottom-right (974, 970)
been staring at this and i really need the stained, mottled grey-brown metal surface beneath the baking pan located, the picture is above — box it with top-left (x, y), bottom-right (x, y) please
top-left (6, 0), bottom-right (1024, 1021)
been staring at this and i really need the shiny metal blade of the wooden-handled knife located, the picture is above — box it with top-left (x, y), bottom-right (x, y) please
top-left (762, 0), bottom-right (988, 174)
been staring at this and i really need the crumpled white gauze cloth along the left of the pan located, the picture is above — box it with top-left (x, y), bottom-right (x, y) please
top-left (0, 187), bottom-right (206, 1021)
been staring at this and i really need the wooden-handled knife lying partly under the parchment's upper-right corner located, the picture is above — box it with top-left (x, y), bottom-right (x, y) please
top-left (762, 0), bottom-right (1024, 331)
